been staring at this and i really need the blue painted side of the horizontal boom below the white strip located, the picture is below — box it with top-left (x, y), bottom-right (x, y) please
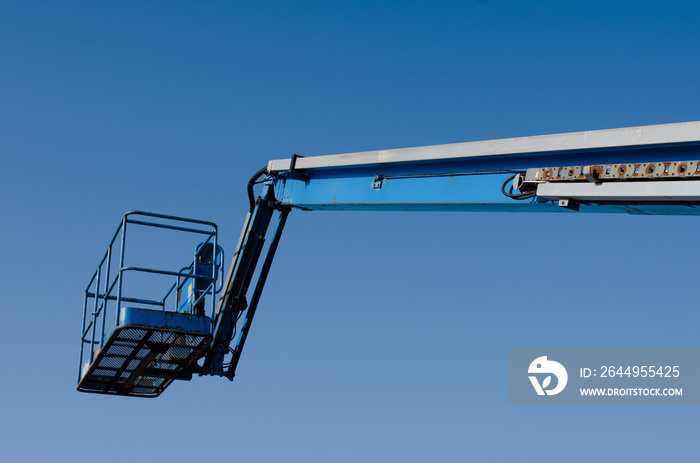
top-left (273, 145), bottom-right (700, 215)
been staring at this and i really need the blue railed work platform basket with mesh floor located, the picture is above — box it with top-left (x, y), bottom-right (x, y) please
top-left (77, 212), bottom-right (223, 397)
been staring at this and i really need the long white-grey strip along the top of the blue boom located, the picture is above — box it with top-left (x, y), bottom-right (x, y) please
top-left (267, 121), bottom-right (700, 173)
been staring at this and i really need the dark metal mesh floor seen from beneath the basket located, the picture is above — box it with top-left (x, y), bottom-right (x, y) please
top-left (78, 325), bottom-right (211, 397)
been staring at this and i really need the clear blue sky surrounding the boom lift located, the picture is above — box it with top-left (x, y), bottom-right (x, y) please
top-left (0, 0), bottom-right (700, 463)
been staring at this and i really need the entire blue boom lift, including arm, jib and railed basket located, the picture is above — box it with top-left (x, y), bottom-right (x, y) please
top-left (78, 122), bottom-right (700, 397)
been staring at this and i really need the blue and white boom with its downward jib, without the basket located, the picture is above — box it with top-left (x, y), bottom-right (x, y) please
top-left (202, 122), bottom-right (700, 379)
